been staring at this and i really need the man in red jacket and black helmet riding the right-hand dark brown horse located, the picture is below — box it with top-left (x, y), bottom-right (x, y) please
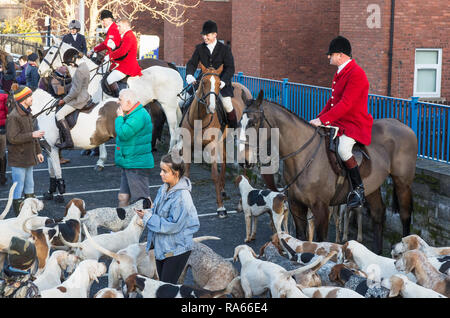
top-left (310, 36), bottom-right (373, 208)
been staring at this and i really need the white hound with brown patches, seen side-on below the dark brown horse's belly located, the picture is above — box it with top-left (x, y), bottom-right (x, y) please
top-left (272, 232), bottom-right (342, 262)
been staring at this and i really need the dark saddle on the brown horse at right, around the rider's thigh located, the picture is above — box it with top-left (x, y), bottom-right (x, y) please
top-left (323, 128), bottom-right (372, 177)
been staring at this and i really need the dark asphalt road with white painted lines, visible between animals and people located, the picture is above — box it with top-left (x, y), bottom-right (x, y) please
top-left (0, 136), bottom-right (271, 294)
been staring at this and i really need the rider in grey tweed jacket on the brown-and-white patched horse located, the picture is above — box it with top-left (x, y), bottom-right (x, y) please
top-left (55, 49), bottom-right (91, 149)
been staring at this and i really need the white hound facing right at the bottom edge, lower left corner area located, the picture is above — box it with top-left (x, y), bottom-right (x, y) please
top-left (41, 259), bottom-right (106, 298)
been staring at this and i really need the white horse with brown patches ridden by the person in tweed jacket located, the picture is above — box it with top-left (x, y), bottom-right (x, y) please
top-left (31, 88), bottom-right (119, 202)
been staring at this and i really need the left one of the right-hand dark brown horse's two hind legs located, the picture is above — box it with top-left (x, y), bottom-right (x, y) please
top-left (366, 188), bottom-right (386, 254)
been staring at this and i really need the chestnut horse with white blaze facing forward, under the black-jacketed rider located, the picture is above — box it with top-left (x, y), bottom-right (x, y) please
top-left (175, 63), bottom-right (252, 218)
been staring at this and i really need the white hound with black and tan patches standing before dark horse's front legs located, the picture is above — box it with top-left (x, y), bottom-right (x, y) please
top-left (234, 175), bottom-right (289, 243)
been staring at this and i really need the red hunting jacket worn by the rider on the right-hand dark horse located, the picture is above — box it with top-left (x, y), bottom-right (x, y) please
top-left (318, 60), bottom-right (373, 145)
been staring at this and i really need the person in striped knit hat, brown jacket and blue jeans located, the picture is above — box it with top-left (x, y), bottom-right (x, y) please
top-left (6, 83), bottom-right (44, 216)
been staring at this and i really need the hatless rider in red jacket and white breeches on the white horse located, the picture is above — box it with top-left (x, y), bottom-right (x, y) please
top-left (106, 18), bottom-right (142, 97)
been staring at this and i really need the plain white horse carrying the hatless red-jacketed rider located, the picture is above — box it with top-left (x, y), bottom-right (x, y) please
top-left (39, 40), bottom-right (183, 151)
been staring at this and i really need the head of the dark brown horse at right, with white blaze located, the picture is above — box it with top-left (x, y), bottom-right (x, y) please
top-left (238, 90), bottom-right (264, 168)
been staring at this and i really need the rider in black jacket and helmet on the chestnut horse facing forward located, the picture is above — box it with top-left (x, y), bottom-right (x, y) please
top-left (186, 20), bottom-right (237, 128)
